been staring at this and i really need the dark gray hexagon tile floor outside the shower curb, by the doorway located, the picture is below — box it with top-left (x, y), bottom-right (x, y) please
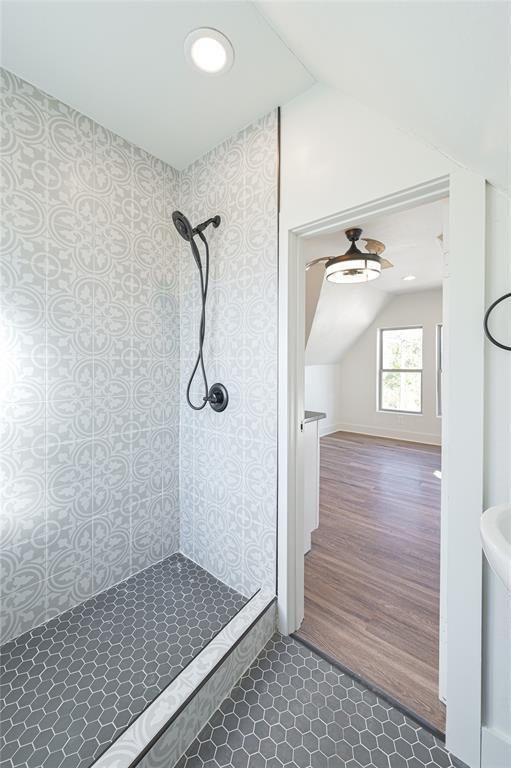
top-left (176, 635), bottom-right (463, 768)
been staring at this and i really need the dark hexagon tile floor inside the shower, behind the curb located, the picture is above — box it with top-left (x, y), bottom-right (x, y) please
top-left (0, 554), bottom-right (247, 768)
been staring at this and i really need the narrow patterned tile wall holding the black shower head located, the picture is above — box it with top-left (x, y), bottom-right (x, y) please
top-left (180, 112), bottom-right (278, 595)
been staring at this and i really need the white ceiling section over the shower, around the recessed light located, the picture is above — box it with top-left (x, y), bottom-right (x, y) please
top-left (1, 0), bottom-right (313, 168)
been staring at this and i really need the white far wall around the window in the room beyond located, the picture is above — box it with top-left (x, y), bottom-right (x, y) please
top-left (336, 289), bottom-right (442, 445)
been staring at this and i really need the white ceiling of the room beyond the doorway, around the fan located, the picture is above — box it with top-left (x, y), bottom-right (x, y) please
top-left (303, 200), bottom-right (447, 365)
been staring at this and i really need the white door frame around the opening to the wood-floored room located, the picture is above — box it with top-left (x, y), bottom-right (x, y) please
top-left (278, 174), bottom-right (486, 768)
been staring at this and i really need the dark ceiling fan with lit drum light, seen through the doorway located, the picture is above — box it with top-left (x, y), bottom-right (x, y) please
top-left (305, 227), bottom-right (394, 283)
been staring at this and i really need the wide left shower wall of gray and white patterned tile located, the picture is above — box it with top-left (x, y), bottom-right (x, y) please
top-left (0, 70), bottom-right (179, 639)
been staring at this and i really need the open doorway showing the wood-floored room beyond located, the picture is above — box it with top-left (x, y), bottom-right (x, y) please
top-left (297, 199), bottom-right (448, 735)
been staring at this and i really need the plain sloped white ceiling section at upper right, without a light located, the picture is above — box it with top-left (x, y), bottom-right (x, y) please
top-left (259, 0), bottom-right (511, 189)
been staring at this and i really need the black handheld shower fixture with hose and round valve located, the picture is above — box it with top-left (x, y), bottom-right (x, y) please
top-left (172, 211), bottom-right (229, 411)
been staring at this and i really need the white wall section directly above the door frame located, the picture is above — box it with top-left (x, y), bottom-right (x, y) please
top-left (281, 85), bottom-right (452, 231)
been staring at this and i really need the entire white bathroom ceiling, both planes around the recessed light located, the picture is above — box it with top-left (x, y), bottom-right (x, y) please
top-left (1, 0), bottom-right (511, 189)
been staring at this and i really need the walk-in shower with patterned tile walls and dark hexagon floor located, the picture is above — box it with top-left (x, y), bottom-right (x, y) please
top-left (0, 70), bottom-right (277, 768)
